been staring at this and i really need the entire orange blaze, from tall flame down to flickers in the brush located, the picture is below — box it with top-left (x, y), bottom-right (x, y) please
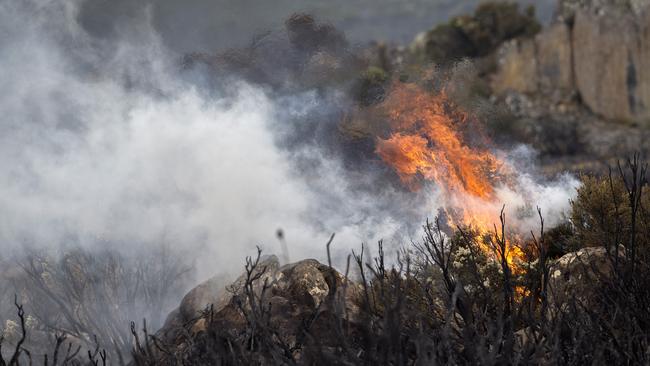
top-left (376, 83), bottom-right (524, 267)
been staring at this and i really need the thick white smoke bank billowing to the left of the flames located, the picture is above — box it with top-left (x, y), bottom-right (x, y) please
top-left (0, 1), bottom-right (424, 276)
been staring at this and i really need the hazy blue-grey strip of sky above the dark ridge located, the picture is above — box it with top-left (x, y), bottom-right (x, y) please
top-left (80, 0), bottom-right (555, 53)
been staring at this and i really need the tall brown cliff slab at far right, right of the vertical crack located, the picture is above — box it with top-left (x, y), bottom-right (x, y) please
top-left (573, 11), bottom-right (650, 120)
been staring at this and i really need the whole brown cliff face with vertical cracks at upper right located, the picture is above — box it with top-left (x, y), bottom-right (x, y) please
top-left (493, 0), bottom-right (650, 122)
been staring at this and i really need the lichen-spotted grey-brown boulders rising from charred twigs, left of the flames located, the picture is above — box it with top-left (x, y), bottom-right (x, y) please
top-left (157, 256), bottom-right (361, 352)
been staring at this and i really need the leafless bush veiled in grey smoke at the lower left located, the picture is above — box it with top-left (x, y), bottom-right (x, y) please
top-left (0, 247), bottom-right (191, 365)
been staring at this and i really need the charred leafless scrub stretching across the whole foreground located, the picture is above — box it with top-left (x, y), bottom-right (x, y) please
top-left (0, 156), bottom-right (650, 365)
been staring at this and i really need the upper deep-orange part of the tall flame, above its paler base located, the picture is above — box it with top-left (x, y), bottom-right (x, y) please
top-left (377, 84), bottom-right (502, 199)
